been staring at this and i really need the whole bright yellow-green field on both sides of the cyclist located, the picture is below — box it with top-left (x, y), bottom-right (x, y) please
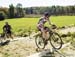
top-left (0, 16), bottom-right (75, 33)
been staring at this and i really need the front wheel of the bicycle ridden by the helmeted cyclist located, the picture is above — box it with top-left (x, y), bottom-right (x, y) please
top-left (50, 32), bottom-right (62, 49)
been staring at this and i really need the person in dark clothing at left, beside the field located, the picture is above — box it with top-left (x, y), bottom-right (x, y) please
top-left (3, 22), bottom-right (13, 39)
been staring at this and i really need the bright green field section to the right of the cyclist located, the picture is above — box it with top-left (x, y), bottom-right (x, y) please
top-left (51, 16), bottom-right (75, 27)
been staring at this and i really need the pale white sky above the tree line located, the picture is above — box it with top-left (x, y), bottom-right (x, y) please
top-left (0, 0), bottom-right (75, 7)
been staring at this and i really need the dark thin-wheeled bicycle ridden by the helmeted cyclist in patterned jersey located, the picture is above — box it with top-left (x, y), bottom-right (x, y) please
top-left (35, 25), bottom-right (62, 49)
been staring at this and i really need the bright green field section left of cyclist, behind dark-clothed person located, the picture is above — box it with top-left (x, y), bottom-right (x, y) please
top-left (0, 18), bottom-right (38, 32)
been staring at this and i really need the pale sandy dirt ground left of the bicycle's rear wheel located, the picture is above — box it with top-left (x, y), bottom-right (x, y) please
top-left (0, 38), bottom-right (36, 57)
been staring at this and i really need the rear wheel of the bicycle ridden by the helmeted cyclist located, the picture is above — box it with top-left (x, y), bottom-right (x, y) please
top-left (35, 35), bottom-right (45, 49)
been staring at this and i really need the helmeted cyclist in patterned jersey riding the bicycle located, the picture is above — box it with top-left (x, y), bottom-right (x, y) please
top-left (37, 12), bottom-right (51, 44)
